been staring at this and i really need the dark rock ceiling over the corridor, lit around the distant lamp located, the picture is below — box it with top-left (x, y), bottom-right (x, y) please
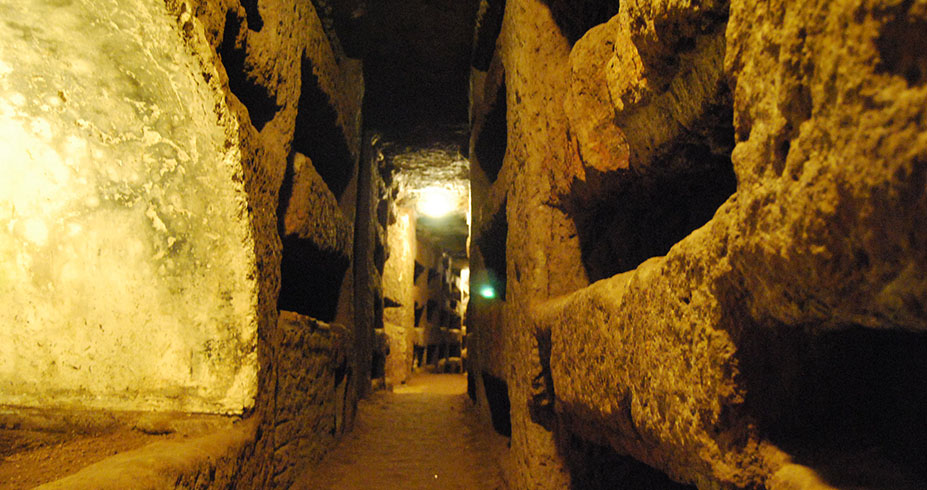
top-left (313, 0), bottom-right (479, 256)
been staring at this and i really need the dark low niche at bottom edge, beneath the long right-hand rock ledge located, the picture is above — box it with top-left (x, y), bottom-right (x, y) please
top-left (558, 434), bottom-right (696, 490)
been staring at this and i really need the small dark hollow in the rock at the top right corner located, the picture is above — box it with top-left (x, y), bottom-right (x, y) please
top-left (876, 0), bottom-right (927, 85)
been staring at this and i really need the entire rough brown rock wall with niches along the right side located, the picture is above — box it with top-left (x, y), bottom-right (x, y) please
top-left (469, 0), bottom-right (927, 489)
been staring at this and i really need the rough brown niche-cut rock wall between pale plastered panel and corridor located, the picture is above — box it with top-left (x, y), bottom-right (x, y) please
top-left (176, 1), bottom-right (378, 488)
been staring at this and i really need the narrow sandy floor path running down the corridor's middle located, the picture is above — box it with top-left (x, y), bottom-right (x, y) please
top-left (294, 374), bottom-right (508, 490)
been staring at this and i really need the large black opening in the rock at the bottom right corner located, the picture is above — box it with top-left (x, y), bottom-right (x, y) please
top-left (737, 325), bottom-right (927, 488)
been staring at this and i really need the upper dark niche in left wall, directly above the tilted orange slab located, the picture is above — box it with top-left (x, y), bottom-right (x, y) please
top-left (293, 56), bottom-right (354, 199)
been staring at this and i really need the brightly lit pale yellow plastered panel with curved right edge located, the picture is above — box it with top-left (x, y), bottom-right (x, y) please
top-left (0, 0), bottom-right (257, 412)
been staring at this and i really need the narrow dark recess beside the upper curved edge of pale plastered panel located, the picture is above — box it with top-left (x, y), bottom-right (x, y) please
top-left (219, 10), bottom-right (280, 131)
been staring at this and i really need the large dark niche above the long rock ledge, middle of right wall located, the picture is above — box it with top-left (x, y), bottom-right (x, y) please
top-left (561, 100), bottom-right (737, 281)
